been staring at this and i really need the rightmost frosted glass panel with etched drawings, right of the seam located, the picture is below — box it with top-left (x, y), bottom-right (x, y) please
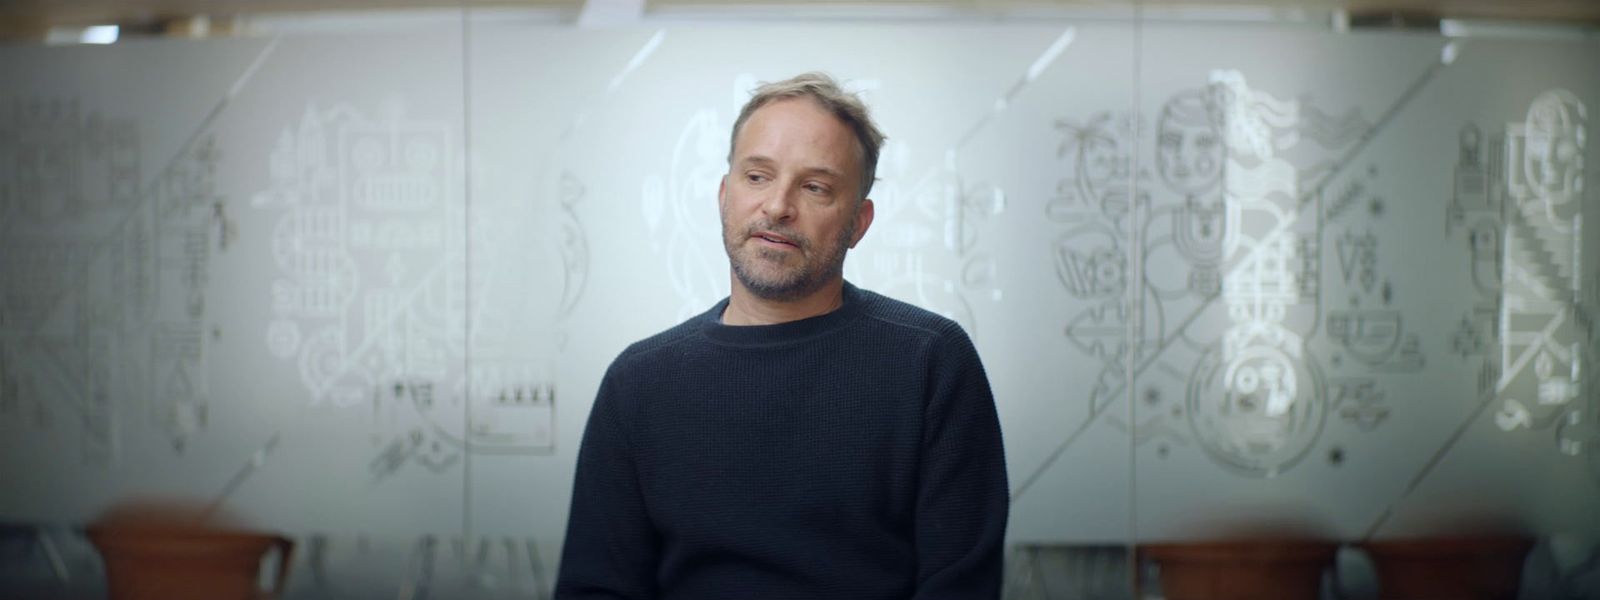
top-left (1130, 27), bottom-right (1600, 539)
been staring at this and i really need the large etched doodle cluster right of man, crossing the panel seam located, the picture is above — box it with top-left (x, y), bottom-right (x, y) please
top-left (1024, 70), bottom-right (1422, 486)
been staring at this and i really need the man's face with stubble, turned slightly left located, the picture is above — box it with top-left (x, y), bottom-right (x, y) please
top-left (718, 98), bottom-right (872, 301)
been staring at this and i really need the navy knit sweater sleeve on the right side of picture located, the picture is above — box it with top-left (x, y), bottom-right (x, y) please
top-left (914, 326), bottom-right (1010, 600)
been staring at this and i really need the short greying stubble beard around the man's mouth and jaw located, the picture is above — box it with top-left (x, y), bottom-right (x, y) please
top-left (722, 216), bottom-right (856, 302)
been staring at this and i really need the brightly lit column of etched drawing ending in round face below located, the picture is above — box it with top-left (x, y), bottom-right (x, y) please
top-left (1187, 72), bottom-right (1326, 477)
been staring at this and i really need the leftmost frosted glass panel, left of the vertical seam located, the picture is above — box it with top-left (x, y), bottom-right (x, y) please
top-left (3, 29), bottom-right (466, 534)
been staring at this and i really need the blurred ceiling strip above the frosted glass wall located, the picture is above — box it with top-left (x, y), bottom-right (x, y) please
top-left (0, 0), bottom-right (1600, 40)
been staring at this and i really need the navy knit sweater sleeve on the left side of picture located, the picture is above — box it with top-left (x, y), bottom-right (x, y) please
top-left (555, 365), bottom-right (659, 600)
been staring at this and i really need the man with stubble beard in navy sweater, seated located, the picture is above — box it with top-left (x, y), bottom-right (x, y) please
top-left (555, 74), bottom-right (1008, 600)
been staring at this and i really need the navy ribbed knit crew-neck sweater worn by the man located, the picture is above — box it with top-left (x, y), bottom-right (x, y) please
top-left (555, 283), bottom-right (1008, 600)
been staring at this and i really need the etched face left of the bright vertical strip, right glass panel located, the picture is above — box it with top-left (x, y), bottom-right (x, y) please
top-left (1155, 91), bottom-right (1224, 194)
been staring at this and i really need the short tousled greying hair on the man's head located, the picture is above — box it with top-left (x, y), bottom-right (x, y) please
top-left (728, 70), bottom-right (885, 200)
